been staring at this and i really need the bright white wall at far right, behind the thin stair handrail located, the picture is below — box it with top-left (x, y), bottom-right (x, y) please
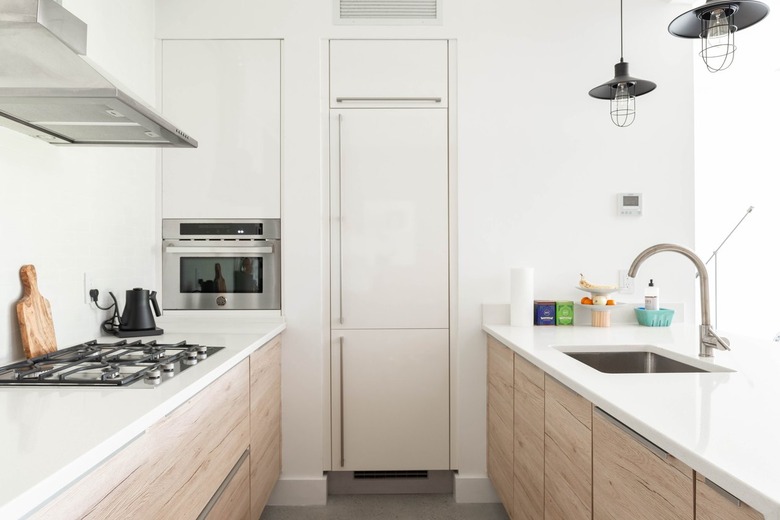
top-left (696, 8), bottom-right (780, 342)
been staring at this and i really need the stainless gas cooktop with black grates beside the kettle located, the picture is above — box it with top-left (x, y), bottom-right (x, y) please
top-left (0, 340), bottom-right (224, 388)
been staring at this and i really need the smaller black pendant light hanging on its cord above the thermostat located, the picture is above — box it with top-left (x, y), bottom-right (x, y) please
top-left (588, 0), bottom-right (655, 126)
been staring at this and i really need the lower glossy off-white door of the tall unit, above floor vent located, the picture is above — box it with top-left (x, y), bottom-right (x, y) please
top-left (331, 330), bottom-right (450, 471)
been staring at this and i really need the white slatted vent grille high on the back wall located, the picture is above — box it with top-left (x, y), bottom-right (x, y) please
top-left (334, 0), bottom-right (442, 25)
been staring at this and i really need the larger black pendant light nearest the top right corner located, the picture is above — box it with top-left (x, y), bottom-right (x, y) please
top-left (669, 0), bottom-right (769, 72)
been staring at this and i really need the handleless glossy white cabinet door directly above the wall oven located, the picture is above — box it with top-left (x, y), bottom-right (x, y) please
top-left (162, 40), bottom-right (281, 218)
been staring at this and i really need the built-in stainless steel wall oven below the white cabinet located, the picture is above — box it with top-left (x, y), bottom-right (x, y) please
top-left (162, 219), bottom-right (282, 310)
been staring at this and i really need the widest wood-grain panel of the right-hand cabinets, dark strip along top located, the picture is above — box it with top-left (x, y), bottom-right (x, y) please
top-left (593, 409), bottom-right (693, 520)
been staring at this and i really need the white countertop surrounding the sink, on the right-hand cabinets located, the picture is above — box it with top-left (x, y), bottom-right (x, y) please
top-left (483, 324), bottom-right (780, 520)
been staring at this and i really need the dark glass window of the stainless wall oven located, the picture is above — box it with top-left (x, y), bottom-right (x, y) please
top-left (179, 256), bottom-right (263, 293)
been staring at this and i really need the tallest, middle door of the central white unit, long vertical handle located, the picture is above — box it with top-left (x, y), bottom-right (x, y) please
top-left (331, 109), bottom-right (449, 329)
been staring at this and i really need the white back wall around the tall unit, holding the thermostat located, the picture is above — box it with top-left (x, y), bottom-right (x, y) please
top-left (157, 0), bottom-right (694, 501)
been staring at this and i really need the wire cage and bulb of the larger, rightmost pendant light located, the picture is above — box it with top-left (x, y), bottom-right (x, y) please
top-left (699, 5), bottom-right (737, 72)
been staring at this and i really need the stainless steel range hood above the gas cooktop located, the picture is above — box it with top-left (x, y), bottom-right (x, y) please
top-left (0, 0), bottom-right (198, 148)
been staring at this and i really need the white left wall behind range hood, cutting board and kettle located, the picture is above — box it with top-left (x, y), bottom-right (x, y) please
top-left (0, 0), bottom-right (157, 363)
